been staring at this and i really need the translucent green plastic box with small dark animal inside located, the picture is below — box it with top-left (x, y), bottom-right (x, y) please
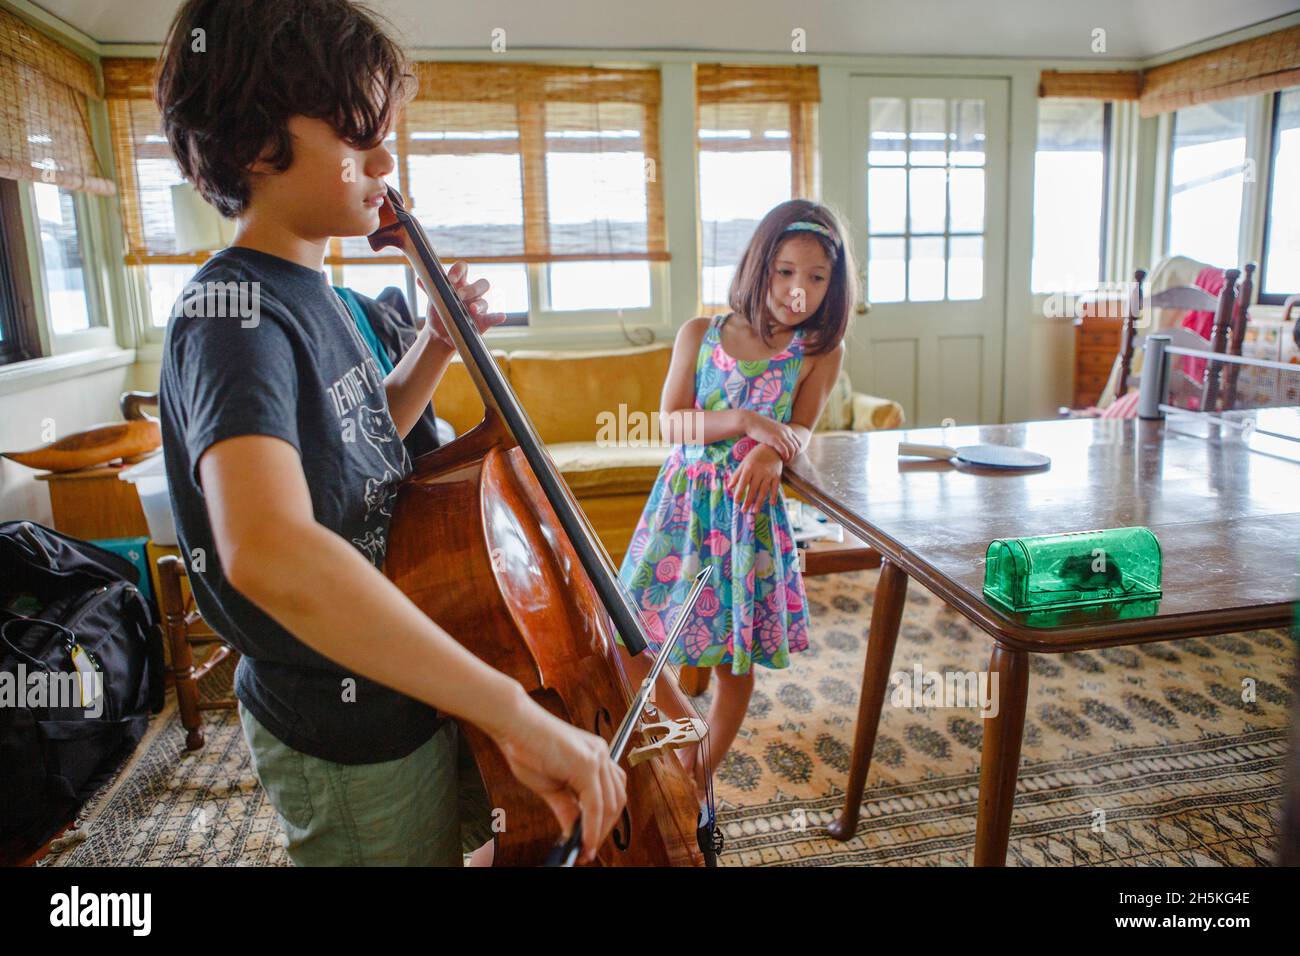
top-left (984, 528), bottom-right (1161, 613)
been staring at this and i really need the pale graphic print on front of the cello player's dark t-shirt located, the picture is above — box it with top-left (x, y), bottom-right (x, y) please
top-left (326, 356), bottom-right (406, 566)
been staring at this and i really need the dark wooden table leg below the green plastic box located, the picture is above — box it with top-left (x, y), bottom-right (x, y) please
top-left (975, 644), bottom-right (1030, 866)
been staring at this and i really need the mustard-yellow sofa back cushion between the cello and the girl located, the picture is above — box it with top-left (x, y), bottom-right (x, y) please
top-left (510, 343), bottom-right (672, 445)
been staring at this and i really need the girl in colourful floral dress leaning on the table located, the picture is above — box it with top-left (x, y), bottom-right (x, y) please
top-left (619, 199), bottom-right (855, 792)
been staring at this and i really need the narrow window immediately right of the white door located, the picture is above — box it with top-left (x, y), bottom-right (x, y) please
top-left (1030, 99), bottom-right (1110, 293)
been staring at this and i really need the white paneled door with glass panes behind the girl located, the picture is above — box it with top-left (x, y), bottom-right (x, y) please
top-left (850, 77), bottom-right (1014, 425)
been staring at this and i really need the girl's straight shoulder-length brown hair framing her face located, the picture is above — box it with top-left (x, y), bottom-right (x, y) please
top-left (727, 199), bottom-right (857, 355)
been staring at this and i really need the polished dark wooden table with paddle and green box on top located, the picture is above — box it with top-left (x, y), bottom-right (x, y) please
top-left (784, 408), bottom-right (1300, 866)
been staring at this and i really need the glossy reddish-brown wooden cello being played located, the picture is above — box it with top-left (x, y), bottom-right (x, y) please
top-left (369, 186), bottom-right (718, 866)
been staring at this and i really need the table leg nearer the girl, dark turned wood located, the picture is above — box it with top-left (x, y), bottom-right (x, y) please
top-left (827, 558), bottom-right (907, 840)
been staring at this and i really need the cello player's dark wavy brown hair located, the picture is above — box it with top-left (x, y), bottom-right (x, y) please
top-left (153, 0), bottom-right (415, 219)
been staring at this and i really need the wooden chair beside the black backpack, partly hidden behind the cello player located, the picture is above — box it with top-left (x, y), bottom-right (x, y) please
top-left (157, 554), bottom-right (239, 752)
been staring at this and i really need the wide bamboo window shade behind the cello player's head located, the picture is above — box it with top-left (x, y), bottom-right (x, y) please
top-left (104, 60), bottom-right (668, 264)
